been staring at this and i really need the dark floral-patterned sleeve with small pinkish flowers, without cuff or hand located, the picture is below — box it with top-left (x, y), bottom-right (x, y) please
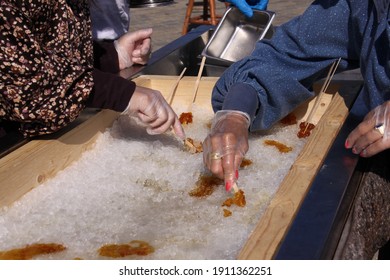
top-left (0, 0), bottom-right (93, 137)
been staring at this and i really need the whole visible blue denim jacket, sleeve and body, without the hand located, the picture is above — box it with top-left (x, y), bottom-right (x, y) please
top-left (212, 0), bottom-right (390, 131)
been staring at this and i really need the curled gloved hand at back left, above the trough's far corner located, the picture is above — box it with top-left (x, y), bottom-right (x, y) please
top-left (114, 28), bottom-right (153, 70)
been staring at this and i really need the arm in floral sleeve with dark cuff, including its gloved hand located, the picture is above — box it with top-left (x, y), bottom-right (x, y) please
top-left (0, 2), bottom-right (184, 137)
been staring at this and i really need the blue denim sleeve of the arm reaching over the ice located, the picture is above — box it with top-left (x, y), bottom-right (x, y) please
top-left (212, 0), bottom-right (367, 131)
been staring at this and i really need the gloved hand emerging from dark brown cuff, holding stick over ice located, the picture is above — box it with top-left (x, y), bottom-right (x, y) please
top-left (124, 86), bottom-right (185, 140)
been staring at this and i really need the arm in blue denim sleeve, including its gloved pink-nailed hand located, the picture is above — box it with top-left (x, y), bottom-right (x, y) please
top-left (203, 1), bottom-right (358, 190)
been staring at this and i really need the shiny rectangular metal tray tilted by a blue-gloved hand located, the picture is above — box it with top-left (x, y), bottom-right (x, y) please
top-left (202, 7), bottom-right (275, 65)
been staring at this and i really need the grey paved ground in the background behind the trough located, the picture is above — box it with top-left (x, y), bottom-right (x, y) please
top-left (130, 0), bottom-right (312, 50)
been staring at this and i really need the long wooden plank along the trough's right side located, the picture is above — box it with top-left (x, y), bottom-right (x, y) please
top-left (238, 86), bottom-right (348, 259)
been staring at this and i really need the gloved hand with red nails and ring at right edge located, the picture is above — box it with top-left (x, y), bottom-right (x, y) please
top-left (345, 101), bottom-right (390, 157)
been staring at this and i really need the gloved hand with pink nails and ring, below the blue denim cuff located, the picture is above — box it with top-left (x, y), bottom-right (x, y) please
top-left (203, 110), bottom-right (250, 191)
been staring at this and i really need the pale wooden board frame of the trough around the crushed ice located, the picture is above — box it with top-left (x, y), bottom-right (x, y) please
top-left (0, 76), bottom-right (349, 259)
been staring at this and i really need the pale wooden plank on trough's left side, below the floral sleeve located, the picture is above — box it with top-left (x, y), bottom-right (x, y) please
top-left (0, 110), bottom-right (118, 207)
